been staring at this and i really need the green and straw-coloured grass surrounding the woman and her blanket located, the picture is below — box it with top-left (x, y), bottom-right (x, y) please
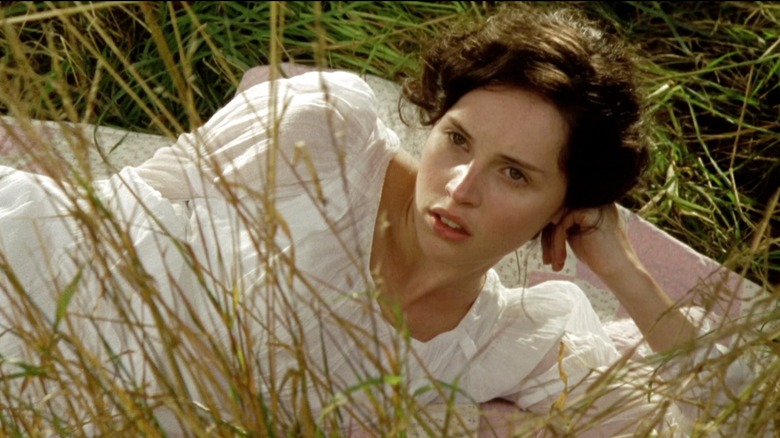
top-left (0, 2), bottom-right (780, 436)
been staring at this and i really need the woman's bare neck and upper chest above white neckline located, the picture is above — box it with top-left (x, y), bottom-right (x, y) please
top-left (371, 153), bottom-right (487, 340)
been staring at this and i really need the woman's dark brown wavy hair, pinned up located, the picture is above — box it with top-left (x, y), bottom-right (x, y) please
top-left (403, 5), bottom-right (649, 208)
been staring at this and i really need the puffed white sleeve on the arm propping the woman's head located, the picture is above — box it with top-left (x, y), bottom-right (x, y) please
top-left (464, 281), bottom-right (618, 400)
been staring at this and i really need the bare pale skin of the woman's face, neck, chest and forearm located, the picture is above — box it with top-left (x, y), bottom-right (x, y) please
top-left (371, 86), bottom-right (696, 352)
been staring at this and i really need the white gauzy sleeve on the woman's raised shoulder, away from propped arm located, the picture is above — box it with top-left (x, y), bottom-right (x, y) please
top-left (138, 72), bottom-right (377, 200)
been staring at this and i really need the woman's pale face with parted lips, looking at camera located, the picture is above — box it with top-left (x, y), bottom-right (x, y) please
top-left (415, 86), bottom-right (568, 267)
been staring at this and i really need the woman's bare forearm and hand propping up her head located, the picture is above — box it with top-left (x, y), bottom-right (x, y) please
top-left (542, 204), bottom-right (697, 352)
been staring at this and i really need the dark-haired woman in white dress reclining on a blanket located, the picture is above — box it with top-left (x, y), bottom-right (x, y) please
top-left (0, 2), bottom-right (744, 433)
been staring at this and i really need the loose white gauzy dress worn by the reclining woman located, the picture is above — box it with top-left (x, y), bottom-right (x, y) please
top-left (0, 73), bottom-right (748, 430)
